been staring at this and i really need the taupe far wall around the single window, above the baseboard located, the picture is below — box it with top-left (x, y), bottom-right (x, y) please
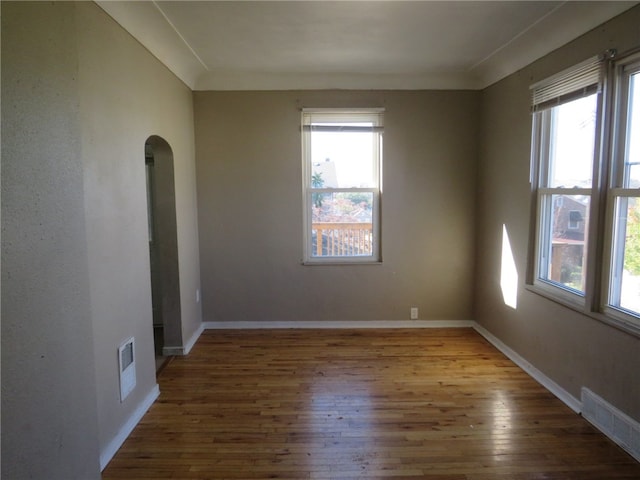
top-left (194, 91), bottom-right (480, 322)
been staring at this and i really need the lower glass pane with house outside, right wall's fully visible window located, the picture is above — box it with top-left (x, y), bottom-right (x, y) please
top-left (539, 195), bottom-right (590, 293)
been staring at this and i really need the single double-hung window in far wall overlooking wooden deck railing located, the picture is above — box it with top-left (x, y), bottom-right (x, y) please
top-left (302, 109), bottom-right (383, 263)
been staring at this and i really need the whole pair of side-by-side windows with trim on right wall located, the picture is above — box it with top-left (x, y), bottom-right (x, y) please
top-left (527, 48), bottom-right (640, 335)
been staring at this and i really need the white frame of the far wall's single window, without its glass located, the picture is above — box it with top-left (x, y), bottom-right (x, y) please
top-left (301, 108), bottom-right (384, 265)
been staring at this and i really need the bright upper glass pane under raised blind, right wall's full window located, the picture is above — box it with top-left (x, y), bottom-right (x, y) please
top-left (547, 94), bottom-right (597, 188)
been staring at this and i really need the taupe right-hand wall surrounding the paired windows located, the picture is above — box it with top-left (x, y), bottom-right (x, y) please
top-left (475, 7), bottom-right (640, 421)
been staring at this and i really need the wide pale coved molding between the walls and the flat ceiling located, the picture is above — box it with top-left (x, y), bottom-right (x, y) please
top-left (96, 0), bottom-right (639, 90)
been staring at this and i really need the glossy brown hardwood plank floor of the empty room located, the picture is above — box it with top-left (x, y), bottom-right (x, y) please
top-left (103, 329), bottom-right (640, 480)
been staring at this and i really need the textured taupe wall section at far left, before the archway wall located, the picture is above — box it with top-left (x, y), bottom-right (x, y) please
top-left (1, 2), bottom-right (100, 480)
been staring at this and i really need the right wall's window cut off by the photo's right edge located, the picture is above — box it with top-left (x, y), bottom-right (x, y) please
top-left (607, 61), bottom-right (640, 317)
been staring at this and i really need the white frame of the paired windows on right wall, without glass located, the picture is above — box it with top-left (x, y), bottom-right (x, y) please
top-left (526, 50), bottom-right (640, 337)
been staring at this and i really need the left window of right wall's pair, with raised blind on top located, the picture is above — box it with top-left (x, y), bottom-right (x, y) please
top-left (532, 59), bottom-right (602, 303)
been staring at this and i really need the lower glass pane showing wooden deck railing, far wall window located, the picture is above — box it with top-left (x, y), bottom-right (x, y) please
top-left (311, 192), bottom-right (374, 257)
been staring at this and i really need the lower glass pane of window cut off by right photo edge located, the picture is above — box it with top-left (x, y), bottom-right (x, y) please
top-left (610, 197), bottom-right (640, 313)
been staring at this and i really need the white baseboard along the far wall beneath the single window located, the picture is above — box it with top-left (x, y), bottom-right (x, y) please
top-left (203, 320), bottom-right (475, 330)
